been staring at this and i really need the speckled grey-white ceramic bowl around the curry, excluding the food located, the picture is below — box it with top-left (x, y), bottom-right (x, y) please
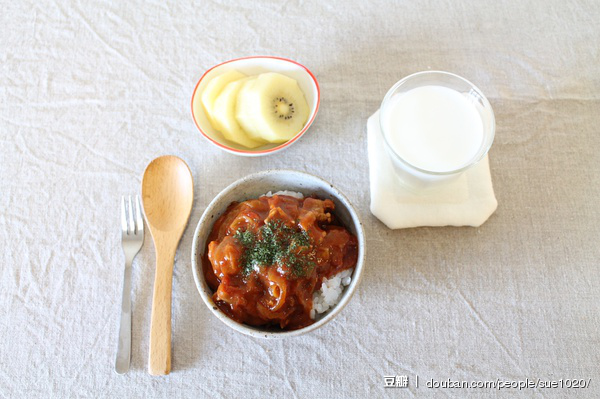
top-left (192, 170), bottom-right (365, 338)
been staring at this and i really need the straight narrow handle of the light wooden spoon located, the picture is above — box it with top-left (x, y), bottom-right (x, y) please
top-left (148, 247), bottom-right (175, 375)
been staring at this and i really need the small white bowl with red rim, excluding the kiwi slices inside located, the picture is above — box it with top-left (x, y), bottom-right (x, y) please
top-left (192, 56), bottom-right (321, 157)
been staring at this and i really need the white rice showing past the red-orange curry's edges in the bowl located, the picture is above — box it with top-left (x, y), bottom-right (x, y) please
top-left (264, 190), bottom-right (354, 320)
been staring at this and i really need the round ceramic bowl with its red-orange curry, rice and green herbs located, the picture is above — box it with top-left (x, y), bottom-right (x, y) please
top-left (192, 170), bottom-right (365, 338)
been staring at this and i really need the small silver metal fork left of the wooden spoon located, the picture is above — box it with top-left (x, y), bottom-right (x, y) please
top-left (115, 195), bottom-right (144, 374)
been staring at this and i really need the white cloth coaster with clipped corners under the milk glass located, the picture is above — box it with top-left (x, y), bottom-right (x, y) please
top-left (367, 111), bottom-right (498, 229)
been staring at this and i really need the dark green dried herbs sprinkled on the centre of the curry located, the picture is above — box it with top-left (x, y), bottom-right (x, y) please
top-left (233, 221), bottom-right (315, 277)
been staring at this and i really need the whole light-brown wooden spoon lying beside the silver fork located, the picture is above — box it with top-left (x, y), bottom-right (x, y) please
top-left (142, 155), bottom-right (194, 375)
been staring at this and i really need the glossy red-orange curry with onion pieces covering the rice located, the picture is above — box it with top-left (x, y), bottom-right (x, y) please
top-left (202, 195), bottom-right (358, 330)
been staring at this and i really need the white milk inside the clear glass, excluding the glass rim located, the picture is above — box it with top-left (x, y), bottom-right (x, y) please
top-left (381, 86), bottom-right (484, 172)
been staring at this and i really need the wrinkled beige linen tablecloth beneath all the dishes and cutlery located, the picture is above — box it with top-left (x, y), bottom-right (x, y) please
top-left (0, 0), bottom-right (600, 398)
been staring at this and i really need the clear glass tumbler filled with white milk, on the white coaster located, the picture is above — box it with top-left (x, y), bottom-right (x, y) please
top-left (379, 71), bottom-right (496, 188)
